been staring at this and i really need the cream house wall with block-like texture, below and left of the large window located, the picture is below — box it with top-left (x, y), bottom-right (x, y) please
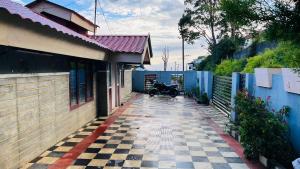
top-left (0, 73), bottom-right (96, 169)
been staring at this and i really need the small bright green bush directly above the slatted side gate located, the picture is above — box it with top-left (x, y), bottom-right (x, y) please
top-left (215, 59), bottom-right (247, 76)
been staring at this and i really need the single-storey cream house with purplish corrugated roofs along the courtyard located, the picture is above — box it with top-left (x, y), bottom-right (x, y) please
top-left (0, 0), bottom-right (152, 169)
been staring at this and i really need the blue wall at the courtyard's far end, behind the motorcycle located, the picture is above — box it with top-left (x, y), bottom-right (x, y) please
top-left (132, 71), bottom-right (197, 92)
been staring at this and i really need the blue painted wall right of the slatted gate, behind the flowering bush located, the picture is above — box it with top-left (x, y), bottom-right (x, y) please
top-left (250, 75), bottom-right (300, 153)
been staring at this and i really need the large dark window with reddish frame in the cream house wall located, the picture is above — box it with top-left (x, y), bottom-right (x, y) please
top-left (70, 62), bottom-right (93, 109)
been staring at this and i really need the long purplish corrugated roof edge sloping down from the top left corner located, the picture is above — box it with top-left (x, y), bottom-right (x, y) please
top-left (0, 0), bottom-right (109, 49)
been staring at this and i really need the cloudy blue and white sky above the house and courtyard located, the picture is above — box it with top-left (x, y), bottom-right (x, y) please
top-left (14, 0), bottom-right (207, 70)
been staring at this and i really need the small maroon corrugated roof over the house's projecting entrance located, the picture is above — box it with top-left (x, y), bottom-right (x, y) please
top-left (91, 35), bottom-right (148, 54)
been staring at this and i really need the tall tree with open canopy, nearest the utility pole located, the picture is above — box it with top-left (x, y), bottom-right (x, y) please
top-left (178, 0), bottom-right (258, 70)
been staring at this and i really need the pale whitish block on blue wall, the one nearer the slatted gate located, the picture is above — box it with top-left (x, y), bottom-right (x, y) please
top-left (254, 68), bottom-right (281, 88)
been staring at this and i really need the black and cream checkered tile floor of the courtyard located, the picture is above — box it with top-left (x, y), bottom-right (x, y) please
top-left (25, 95), bottom-right (248, 169)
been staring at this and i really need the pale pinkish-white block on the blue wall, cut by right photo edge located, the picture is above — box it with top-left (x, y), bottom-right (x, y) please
top-left (281, 68), bottom-right (300, 94)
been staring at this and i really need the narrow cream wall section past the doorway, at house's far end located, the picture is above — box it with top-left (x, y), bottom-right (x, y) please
top-left (120, 70), bottom-right (132, 103)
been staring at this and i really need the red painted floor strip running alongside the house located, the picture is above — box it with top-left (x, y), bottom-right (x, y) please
top-left (48, 94), bottom-right (140, 169)
